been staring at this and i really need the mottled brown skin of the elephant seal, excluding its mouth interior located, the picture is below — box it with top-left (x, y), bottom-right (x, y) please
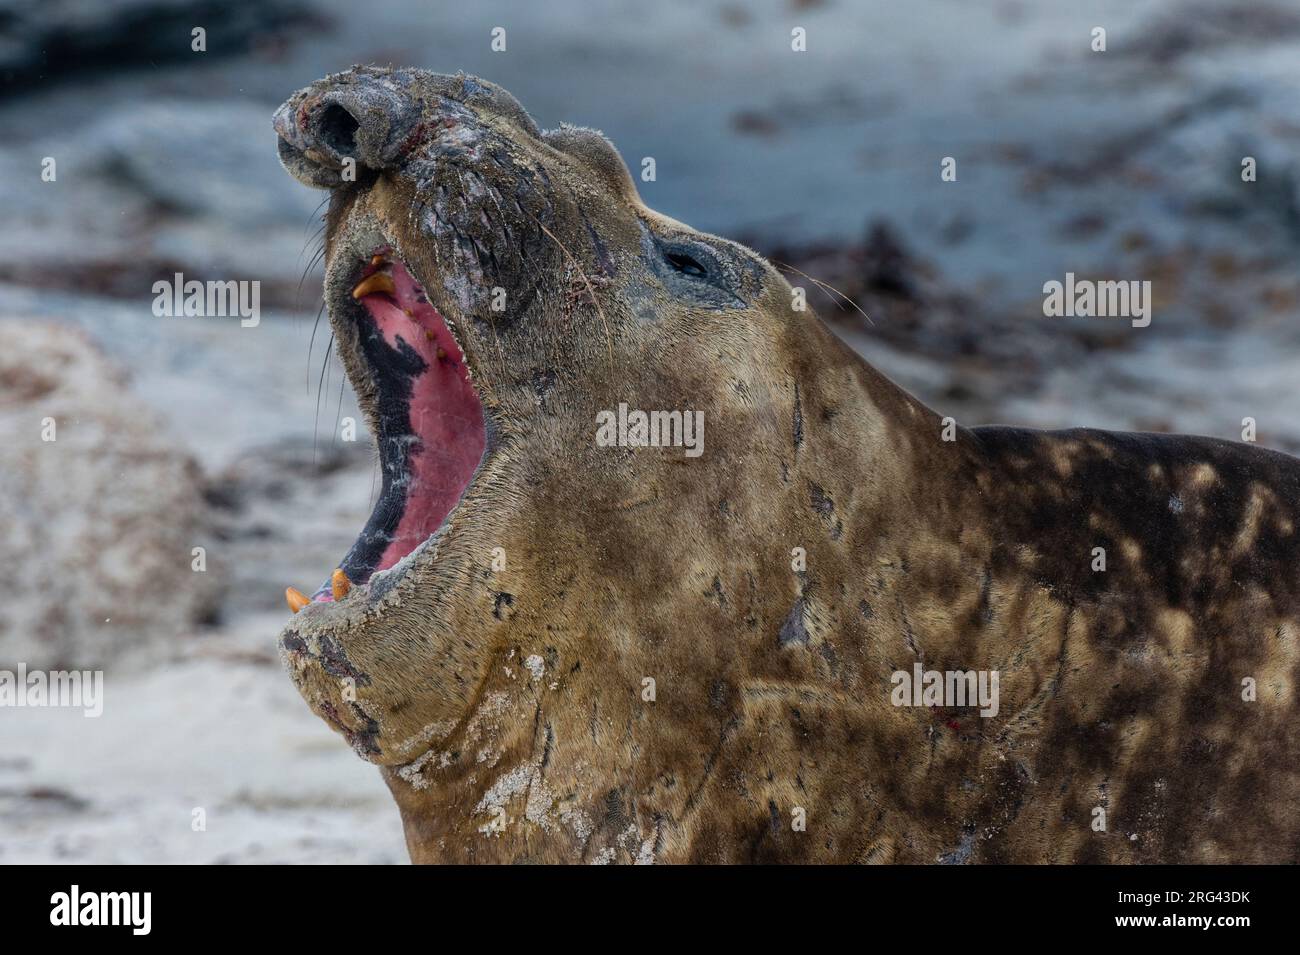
top-left (269, 68), bottom-right (1300, 863)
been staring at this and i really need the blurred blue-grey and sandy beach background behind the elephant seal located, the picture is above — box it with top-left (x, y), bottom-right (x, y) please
top-left (0, 0), bottom-right (1300, 863)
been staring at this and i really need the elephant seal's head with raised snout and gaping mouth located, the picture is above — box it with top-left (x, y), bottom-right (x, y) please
top-left (274, 66), bottom-right (821, 784)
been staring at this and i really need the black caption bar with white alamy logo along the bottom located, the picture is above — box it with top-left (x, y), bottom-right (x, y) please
top-left (0, 865), bottom-right (1279, 949)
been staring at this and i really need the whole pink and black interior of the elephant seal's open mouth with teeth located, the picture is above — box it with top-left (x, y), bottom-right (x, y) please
top-left (290, 244), bottom-right (488, 611)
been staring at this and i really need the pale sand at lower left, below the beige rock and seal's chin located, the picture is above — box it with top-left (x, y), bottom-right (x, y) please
top-left (0, 641), bottom-right (406, 863)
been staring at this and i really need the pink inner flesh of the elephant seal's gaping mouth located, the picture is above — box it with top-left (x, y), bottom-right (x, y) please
top-left (361, 261), bottom-right (488, 570)
